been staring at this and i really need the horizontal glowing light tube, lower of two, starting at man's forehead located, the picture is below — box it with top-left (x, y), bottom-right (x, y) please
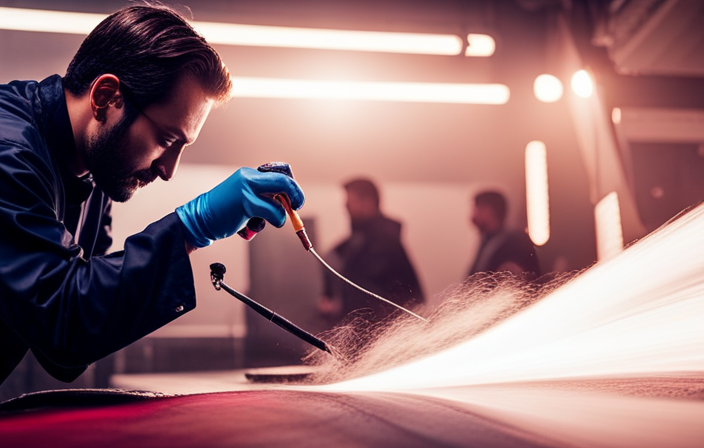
top-left (232, 77), bottom-right (510, 104)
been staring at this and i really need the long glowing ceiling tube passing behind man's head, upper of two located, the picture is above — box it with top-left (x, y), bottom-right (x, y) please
top-left (0, 7), bottom-right (472, 56)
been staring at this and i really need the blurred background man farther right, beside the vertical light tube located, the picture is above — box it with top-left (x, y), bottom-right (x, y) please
top-left (468, 191), bottom-right (540, 278)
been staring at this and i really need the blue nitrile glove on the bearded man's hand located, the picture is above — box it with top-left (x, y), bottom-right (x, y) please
top-left (176, 168), bottom-right (305, 247)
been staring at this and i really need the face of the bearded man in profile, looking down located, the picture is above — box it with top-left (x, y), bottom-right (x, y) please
top-left (83, 77), bottom-right (213, 202)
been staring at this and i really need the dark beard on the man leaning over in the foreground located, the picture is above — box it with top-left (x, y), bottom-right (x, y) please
top-left (83, 111), bottom-right (157, 202)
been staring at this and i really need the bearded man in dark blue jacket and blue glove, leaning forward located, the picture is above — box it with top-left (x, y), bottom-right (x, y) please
top-left (0, 4), bottom-right (304, 382)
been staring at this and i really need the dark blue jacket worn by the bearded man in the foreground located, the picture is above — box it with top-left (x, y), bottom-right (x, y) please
top-left (0, 75), bottom-right (195, 383)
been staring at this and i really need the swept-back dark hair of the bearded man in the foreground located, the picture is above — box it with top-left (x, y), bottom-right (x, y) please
top-left (63, 2), bottom-right (232, 109)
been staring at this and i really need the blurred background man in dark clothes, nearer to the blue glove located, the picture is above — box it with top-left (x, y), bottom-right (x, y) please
top-left (319, 179), bottom-right (424, 323)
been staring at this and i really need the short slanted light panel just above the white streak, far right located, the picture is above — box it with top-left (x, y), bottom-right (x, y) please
top-left (594, 191), bottom-right (623, 261)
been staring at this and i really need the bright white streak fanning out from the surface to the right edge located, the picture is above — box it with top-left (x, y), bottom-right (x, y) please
top-left (325, 200), bottom-right (704, 391)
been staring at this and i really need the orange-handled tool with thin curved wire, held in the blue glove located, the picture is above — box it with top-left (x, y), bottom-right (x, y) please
top-left (245, 162), bottom-right (426, 321)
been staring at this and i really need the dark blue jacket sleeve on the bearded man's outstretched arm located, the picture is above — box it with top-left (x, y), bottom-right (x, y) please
top-left (0, 141), bottom-right (195, 379)
